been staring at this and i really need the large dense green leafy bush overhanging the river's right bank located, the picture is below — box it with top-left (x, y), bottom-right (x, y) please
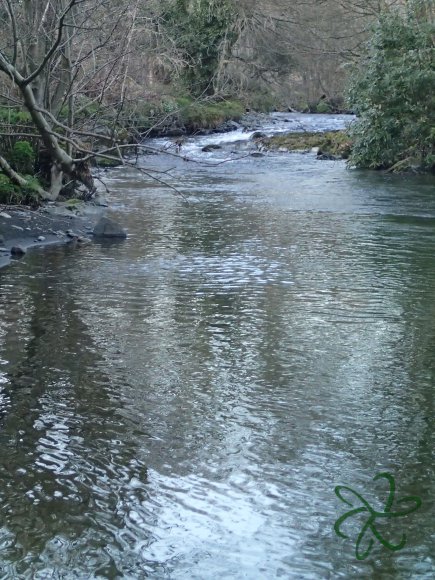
top-left (349, 0), bottom-right (435, 170)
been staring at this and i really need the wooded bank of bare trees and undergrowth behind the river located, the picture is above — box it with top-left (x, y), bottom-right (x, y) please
top-left (0, 0), bottom-right (435, 199)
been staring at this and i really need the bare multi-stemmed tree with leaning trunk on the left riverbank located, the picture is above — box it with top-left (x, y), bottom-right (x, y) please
top-left (0, 0), bottom-right (137, 200)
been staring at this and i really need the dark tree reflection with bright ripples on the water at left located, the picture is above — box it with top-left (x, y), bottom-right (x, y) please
top-left (0, 253), bottom-right (147, 578)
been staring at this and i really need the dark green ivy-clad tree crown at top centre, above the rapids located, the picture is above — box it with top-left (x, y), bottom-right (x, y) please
top-left (163, 0), bottom-right (237, 96)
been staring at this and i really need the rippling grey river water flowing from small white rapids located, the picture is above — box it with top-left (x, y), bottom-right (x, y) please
top-left (0, 115), bottom-right (435, 580)
